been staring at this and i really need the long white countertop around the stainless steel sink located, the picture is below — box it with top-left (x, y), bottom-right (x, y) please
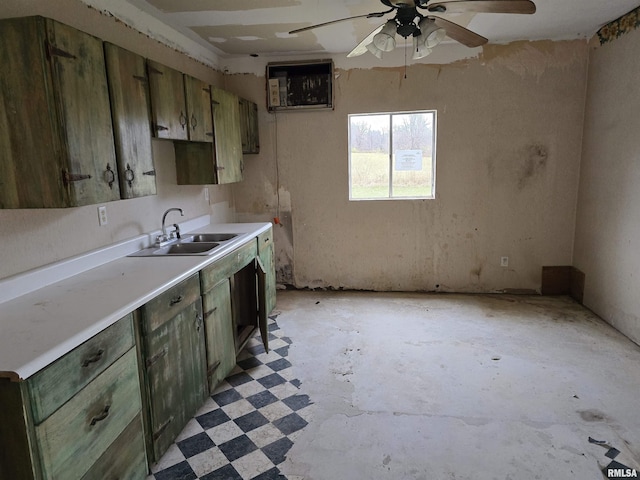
top-left (0, 219), bottom-right (271, 381)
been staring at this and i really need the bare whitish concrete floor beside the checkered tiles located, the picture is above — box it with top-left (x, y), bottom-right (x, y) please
top-left (277, 291), bottom-right (640, 480)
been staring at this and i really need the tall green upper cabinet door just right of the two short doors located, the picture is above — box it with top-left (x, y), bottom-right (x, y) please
top-left (211, 87), bottom-right (243, 184)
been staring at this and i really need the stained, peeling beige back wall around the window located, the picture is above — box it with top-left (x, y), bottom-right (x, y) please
top-left (225, 41), bottom-right (587, 292)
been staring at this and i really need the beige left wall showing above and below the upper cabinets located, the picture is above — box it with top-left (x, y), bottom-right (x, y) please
top-left (0, 0), bottom-right (235, 278)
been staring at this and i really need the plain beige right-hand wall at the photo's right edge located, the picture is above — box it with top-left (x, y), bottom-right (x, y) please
top-left (574, 30), bottom-right (640, 343)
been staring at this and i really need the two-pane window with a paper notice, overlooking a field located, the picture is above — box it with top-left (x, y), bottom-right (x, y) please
top-left (349, 110), bottom-right (436, 200)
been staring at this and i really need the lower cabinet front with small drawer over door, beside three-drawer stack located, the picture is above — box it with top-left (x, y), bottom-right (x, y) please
top-left (140, 274), bottom-right (208, 461)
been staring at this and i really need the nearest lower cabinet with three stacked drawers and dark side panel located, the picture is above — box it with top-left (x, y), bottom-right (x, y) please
top-left (0, 315), bottom-right (147, 479)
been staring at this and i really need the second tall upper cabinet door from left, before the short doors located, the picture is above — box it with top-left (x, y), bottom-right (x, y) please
top-left (104, 43), bottom-right (156, 198)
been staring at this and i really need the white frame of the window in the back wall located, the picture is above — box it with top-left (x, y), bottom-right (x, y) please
top-left (347, 109), bottom-right (438, 202)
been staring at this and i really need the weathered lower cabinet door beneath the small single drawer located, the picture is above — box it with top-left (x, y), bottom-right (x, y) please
top-left (144, 299), bottom-right (207, 461)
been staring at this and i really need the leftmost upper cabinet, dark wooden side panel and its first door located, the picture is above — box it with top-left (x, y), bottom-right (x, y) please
top-left (0, 17), bottom-right (120, 208)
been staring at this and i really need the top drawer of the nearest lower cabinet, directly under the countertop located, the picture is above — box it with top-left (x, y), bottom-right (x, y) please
top-left (27, 314), bottom-right (134, 425)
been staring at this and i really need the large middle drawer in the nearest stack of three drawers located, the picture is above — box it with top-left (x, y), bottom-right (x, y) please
top-left (35, 348), bottom-right (141, 479)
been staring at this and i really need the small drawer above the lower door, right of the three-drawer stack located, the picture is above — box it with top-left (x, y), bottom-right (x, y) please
top-left (141, 273), bottom-right (200, 333)
